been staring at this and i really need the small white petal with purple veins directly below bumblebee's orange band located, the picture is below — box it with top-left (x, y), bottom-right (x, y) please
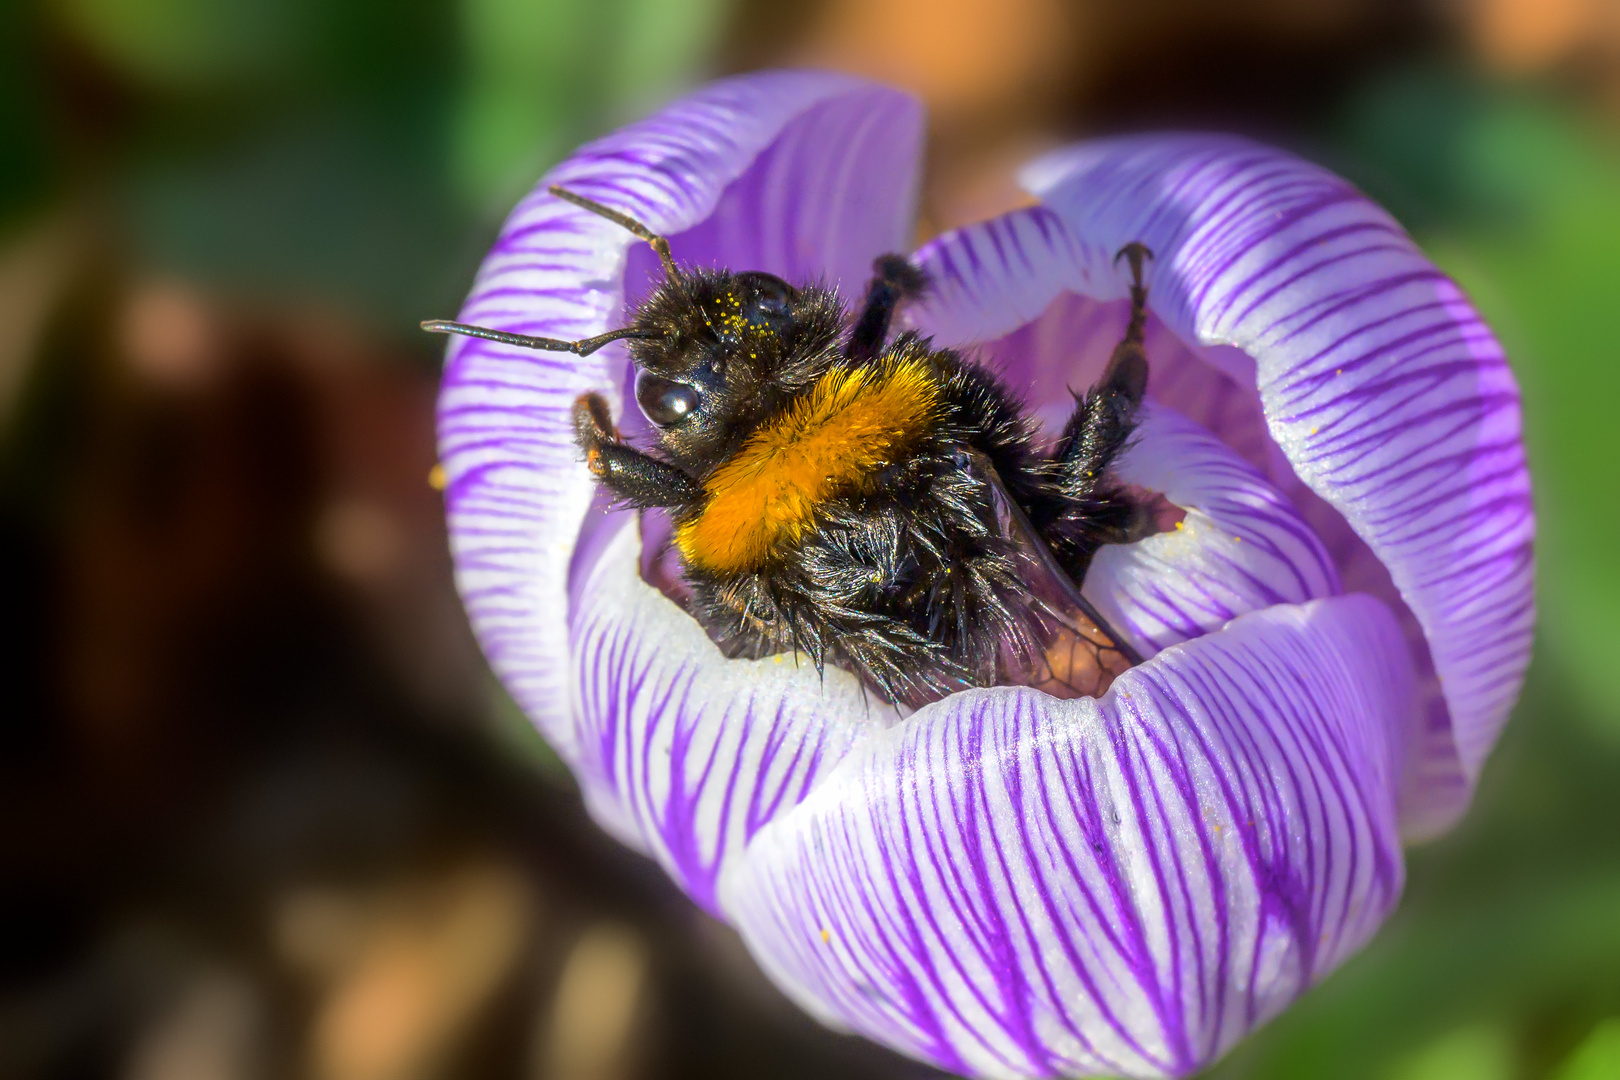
top-left (569, 515), bottom-right (896, 915)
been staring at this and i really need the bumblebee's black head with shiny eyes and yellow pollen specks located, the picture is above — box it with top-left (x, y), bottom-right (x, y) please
top-left (630, 270), bottom-right (842, 473)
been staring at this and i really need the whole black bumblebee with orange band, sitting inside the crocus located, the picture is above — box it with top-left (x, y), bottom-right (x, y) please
top-left (423, 186), bottom-right (1152, 706)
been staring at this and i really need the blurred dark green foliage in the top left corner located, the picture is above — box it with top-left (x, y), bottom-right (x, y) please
top-left (15, 0), bottom-right (726, 338)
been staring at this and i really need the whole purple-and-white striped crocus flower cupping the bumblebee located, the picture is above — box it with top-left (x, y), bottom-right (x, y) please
top-left (439, 73), bottom-right (1534, 1077)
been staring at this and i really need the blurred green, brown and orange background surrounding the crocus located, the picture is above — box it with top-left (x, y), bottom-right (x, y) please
top-left (0, 0), bottom-right (1620, 1080)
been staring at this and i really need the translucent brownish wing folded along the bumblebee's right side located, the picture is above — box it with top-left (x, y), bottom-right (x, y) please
top-left (969, 450), bottom-right (1142, 698)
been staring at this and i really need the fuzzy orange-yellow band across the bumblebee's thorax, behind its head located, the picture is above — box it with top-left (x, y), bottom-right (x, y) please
top-left (676, 358), bottom-right (940, 573)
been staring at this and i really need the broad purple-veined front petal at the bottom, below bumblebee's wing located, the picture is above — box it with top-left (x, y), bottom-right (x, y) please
top-left (721, 596), bottom-right (1411, 1077)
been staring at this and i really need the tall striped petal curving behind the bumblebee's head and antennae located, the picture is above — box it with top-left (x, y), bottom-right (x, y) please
top-left (439, 73), bottom-right (922, 767)
